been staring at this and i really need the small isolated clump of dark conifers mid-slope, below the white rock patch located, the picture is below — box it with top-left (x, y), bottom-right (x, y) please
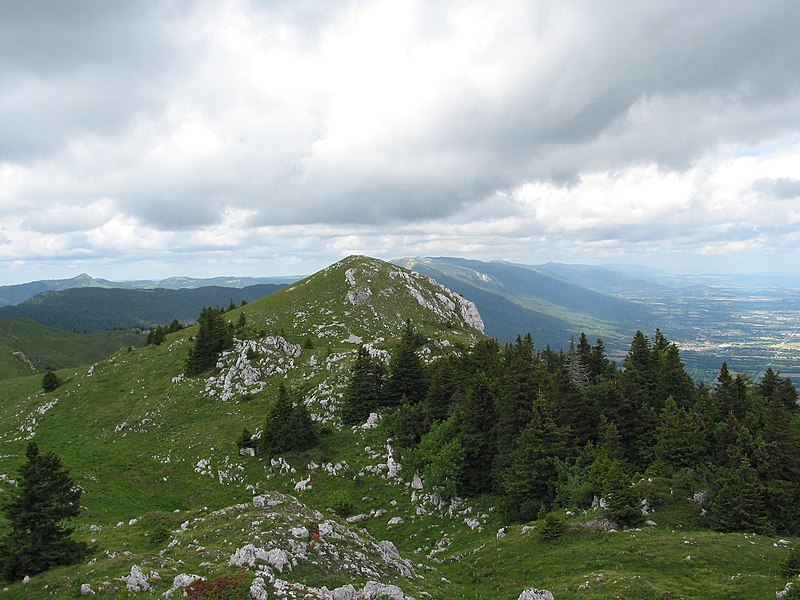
top-left (261, 384), bottom-right (317, 457)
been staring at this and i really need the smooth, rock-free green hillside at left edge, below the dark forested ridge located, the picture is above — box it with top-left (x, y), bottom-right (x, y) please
top-left (0, 318), bottom-right (145, 379)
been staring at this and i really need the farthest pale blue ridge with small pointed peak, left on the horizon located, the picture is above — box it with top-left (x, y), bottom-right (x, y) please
top-left (0, 273), bottom-right (299, 307)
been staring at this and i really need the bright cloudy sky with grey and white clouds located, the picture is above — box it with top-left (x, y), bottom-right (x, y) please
top-left (0, 0), bottom-right (800, 284)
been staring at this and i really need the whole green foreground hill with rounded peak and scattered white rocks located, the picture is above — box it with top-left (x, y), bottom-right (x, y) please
top-left (0, 257), bottom-right (787, 600)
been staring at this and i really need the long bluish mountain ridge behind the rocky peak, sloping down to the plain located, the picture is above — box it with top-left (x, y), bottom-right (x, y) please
top-left (396, 258), bottom-right (654, 352)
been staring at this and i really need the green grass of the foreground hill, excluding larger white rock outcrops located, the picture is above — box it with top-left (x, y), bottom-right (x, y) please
top-left (0, 255), bottom-right (786, 600)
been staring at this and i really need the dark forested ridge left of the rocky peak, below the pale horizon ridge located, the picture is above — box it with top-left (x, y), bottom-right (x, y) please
top-left (0, 284), bottom-right (283, 333)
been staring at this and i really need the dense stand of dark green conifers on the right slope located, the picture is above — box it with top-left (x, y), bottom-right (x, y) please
top-left (342, 323), bottom-right (800, 533)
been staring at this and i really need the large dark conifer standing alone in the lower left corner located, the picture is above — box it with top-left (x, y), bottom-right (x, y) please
top-left (0, 443), bottom-right (88, 581)
